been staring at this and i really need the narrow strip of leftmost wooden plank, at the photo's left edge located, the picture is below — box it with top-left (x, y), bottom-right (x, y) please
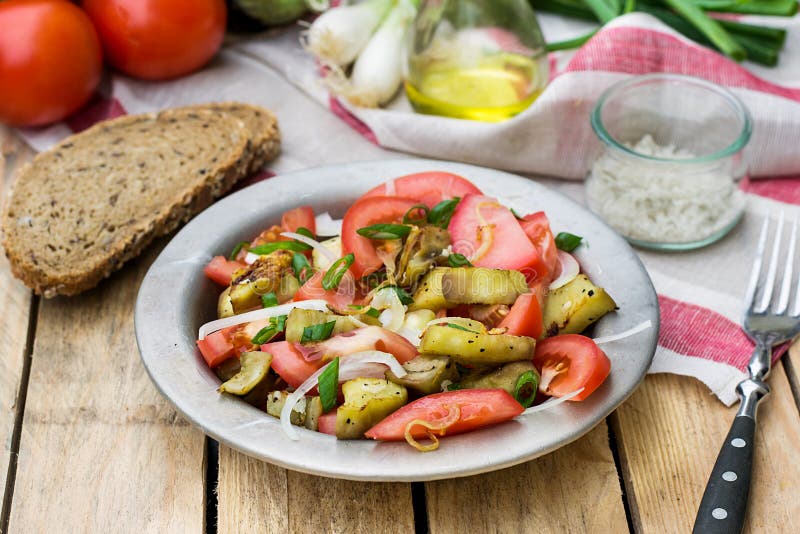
top-left (0, 130), bottom-right (32, 506)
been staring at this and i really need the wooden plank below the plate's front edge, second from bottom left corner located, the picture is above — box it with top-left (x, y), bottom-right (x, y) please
top-left (217, 445), bottom-right (414, 534)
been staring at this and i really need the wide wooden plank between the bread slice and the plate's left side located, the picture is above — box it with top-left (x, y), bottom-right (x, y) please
top-left (10, 246), bottom-right (205, 533)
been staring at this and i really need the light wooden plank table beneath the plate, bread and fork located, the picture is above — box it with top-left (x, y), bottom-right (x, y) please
top-left (0, 131), bottom-right (800, 534)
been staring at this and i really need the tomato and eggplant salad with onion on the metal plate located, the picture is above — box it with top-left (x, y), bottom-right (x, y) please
top-left (197, 172), bottom-right (616, 450)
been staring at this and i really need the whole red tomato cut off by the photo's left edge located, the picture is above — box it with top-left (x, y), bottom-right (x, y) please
top-left (0, 0), bottom-right (103, 126)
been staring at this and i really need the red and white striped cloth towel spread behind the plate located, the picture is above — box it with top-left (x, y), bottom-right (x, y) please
top-left (15, 14), bottom-right (800, 404)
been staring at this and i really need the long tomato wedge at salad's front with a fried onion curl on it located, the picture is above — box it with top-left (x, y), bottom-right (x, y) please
top-left (365, 389), bottom-right (525, 441)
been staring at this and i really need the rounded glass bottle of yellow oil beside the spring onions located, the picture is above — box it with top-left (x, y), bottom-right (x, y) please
top-left (405, 0), bottom-right (549, 122)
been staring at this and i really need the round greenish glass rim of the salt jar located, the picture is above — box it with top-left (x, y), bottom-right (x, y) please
top-left (591, 73), bottom-right (753, 164)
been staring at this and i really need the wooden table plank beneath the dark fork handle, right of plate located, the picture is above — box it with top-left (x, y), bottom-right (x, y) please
top-left (612, 365), bottom-right (800, 533)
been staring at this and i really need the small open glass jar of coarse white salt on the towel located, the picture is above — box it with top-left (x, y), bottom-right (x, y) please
top-left (586, 74), bottom-right (752, 250)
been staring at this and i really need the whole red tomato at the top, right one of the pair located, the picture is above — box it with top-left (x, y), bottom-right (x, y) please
top-left (83, 0), bottom-right (227, 80)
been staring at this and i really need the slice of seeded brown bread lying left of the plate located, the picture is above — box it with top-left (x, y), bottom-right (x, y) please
top-left (2, 107), bottom-right (260, 297)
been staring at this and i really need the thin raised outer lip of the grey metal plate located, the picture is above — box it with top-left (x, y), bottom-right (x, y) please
top-left (134, 158), bottom-right (660, 482)
